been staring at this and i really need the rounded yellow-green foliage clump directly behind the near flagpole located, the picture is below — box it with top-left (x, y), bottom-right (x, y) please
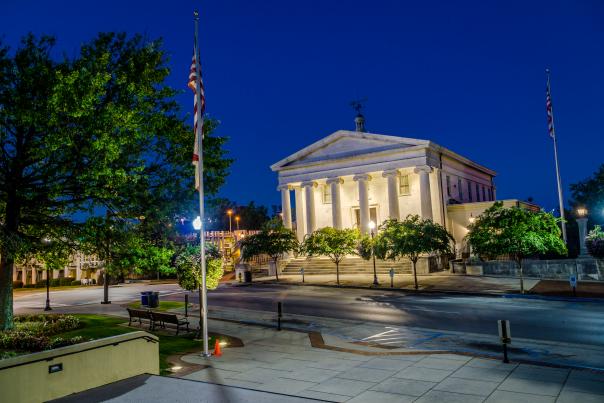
top-left (175, 243), bottom-right (224, 291)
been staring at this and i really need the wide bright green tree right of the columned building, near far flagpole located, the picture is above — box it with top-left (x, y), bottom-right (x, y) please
top-left (466, 202), bottom-right (566, 293)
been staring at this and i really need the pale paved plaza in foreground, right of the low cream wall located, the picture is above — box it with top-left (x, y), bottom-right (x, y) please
top-left (182, 320), bottom-right (604, 403)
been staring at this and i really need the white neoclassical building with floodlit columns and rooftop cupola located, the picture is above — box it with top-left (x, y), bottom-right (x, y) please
top-left (271, 117), bottom-right (504, 252)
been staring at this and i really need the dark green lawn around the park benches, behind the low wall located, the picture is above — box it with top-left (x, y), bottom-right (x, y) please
top-left (56, 314), bottom-right (214, 375)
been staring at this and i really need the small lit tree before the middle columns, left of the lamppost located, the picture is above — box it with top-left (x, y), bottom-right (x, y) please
top-left (301, 227), bottom-right (360, 285)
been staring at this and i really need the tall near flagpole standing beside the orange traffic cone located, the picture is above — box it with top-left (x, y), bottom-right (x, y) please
top-left (193, 10), bottom-right (210, 357)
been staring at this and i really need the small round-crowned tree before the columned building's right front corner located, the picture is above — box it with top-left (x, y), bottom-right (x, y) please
top-left (375, 215), bottom-right (455, 290)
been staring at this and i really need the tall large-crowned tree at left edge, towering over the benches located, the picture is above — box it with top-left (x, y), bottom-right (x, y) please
top-left (0, 33), bottom-right (231, 330)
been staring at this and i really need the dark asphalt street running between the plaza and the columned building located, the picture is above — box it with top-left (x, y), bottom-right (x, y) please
top-left (15, 284), bottom-right (604, 347)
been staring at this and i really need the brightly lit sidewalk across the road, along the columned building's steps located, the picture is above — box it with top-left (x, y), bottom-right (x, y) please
top-left (249, 273), bottom-right (540, 294)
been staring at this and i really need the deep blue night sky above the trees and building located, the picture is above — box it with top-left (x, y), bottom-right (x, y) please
top-left (0, 0), bottom-right (604, 213)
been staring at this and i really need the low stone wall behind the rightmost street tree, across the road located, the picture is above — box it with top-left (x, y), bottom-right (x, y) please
top-left (450, 258), bottom-right (604, 281)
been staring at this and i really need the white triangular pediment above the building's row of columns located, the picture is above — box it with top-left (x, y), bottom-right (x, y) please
top-left (271, 130), bottom-right (429, 171)
